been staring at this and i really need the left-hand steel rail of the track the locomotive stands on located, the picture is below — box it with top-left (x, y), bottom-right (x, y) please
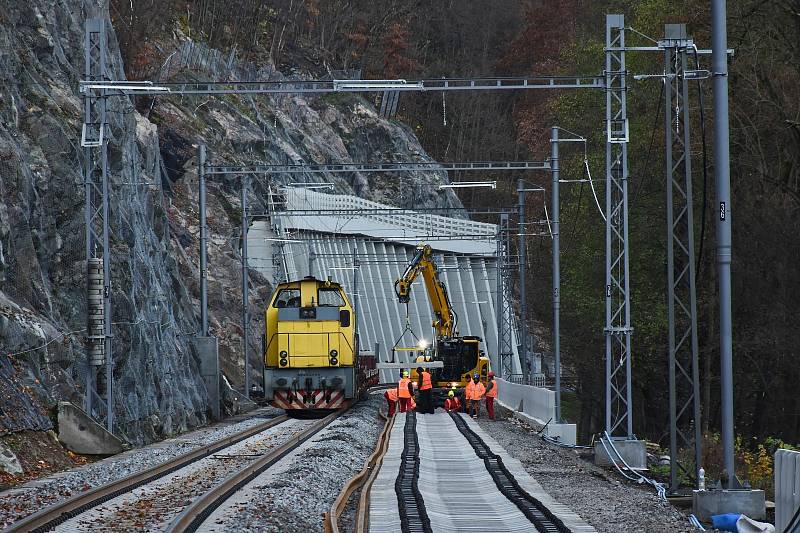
top-left (3, 415), bottom-right (288, 533)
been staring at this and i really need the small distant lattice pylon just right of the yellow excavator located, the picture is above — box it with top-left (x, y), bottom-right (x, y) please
top-left (495, 215), bottom-right (514, 379)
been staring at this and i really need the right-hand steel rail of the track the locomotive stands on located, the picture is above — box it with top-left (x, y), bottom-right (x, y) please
top-left (166, 401), bottom-right (354, 533)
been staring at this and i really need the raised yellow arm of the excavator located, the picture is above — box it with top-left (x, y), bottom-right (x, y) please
top-left (394, 244), bottom-right (457, 339)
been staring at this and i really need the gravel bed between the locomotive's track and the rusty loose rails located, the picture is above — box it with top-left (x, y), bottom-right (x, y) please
top-left (199, 391), bottom-right (386, 533)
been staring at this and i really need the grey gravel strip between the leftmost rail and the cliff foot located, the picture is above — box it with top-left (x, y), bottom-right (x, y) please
top-left (0, 407), bottom-right (283, 529)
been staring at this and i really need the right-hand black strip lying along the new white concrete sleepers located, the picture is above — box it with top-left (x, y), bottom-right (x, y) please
top-left (450, 413), bottom-right (571, 533)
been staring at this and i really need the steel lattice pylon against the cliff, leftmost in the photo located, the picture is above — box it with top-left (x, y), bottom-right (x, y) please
top-left (81, 19), bottom-right (114, 431)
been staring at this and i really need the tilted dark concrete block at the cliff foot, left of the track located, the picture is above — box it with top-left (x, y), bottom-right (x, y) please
top-left (58, 402), bottom-right (123, 455)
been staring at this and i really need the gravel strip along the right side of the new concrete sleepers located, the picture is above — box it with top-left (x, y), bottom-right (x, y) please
top-left (479, 409), bottom-right (689, 533)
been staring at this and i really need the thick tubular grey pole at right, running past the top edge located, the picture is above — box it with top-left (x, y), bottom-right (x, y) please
top-left (711, 0), bottom-right (736, 481)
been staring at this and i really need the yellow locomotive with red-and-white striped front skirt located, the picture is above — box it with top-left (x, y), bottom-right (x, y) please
top-left (264, 276), bottom-right (378, 412)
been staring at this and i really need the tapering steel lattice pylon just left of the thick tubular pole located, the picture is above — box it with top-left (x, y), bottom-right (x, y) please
top-left (660, 24), bottom-right (701, 492)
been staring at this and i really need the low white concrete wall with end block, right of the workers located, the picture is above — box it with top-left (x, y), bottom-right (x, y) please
top-left (495, 378), bottom-right (577, 444)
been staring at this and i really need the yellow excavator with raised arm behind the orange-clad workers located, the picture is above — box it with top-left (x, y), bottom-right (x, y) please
top-left (394, 244), bottom-right (489, 388)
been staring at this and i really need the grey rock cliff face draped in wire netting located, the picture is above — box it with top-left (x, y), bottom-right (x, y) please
top-left (0, 0), bottom-right (459, 443)
